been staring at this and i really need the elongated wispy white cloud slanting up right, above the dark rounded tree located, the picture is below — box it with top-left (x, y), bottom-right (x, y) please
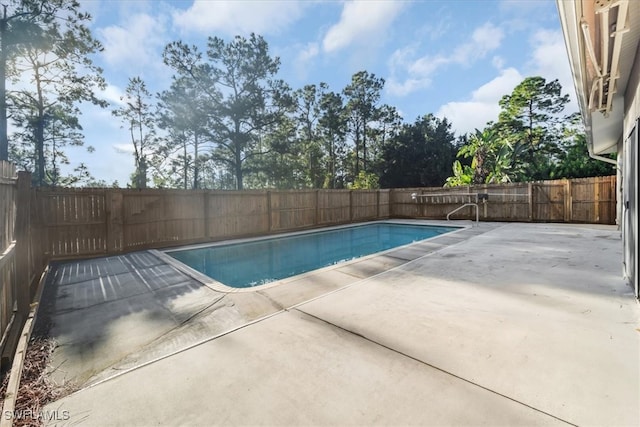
top-left (387, 23), bottom-right (504, 96)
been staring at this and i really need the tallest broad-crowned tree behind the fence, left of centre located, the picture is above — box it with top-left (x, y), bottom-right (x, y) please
top-left (164, 34), bottom-right (291, 189)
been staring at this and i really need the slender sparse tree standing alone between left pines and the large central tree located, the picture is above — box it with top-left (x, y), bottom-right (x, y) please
top-left (112, 77), bottom-right (157, 188)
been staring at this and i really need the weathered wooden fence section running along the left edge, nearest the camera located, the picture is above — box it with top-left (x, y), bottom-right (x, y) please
top-left (0, 166), bottom-right (48, 370)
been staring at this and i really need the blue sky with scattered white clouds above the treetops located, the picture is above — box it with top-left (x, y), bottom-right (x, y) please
top-left (56, 0), bottom-right (578, 186)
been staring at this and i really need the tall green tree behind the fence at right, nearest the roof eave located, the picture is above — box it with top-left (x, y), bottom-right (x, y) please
top-left (496, 76), bottom-right (571, 181)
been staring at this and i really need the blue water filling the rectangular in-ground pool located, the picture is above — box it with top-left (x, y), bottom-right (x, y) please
top-left (167, 223), bottom-right (457, 288)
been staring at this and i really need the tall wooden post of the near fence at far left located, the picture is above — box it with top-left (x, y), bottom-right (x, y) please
top-left (15, 172), bottom-right (31, 325)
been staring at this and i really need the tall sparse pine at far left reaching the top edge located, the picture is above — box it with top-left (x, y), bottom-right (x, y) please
top-left (0, 0), bottom-right (107, 185)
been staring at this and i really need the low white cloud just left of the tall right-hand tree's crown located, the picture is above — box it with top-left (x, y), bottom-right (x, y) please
top-left (436, 68), bottom-right (524, 135)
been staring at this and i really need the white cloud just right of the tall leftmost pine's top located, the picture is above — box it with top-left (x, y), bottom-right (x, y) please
top-left (97, 13), bottom-right (165, 72)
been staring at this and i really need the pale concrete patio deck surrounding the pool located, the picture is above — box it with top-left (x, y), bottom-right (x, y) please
top-left (38, 223), bottom-right (640, 426)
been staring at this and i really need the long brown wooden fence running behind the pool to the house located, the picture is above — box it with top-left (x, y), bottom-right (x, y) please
top-left (31, 176), bottom-right (616, 259)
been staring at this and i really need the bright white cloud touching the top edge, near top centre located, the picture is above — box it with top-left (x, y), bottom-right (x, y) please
top-left (322, 0), bottom-right (406, 52)
